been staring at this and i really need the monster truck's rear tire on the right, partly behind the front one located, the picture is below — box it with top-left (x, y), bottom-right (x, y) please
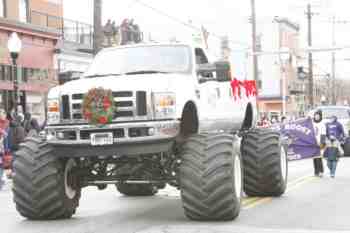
top-left (241, 129), bottom-right (288, 196)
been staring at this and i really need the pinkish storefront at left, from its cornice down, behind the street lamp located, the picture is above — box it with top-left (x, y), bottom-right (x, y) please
top-left (0, 20), bottom-right (59, 120)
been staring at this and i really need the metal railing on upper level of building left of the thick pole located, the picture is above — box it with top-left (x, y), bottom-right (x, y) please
top-left (30, 10), bottom-right (93, 47)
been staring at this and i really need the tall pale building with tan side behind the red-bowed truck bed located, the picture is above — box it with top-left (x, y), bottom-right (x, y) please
top-left (253, 18), bottom-right (305, 120)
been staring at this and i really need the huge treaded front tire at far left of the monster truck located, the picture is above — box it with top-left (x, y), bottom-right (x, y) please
top-left (13, 138), bottom-right (81, 220)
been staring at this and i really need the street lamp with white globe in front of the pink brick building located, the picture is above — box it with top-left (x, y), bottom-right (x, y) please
top-left (7, 32), bottom-right (22, 116)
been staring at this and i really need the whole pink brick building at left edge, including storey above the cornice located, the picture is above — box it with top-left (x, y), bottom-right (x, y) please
top-left (0, 0), bottom-right (63, 120)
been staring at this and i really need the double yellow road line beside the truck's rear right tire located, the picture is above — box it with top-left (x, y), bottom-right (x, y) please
top-left (242, 176), bottom-right (317, 210)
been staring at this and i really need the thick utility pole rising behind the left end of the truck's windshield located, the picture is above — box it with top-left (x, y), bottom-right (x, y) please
top-left (93, 0), bottom-right (103, 55)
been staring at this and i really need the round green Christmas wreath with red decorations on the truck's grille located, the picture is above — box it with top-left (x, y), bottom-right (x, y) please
top-left (83, 87), bottom-right (115, 125)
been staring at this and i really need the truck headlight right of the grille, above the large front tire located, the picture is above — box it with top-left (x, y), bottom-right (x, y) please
top-left (153, 92), bottom-right (176, 119)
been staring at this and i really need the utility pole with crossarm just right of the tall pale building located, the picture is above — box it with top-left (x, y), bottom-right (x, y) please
top-left (306, 3), bottom-right (314, 108)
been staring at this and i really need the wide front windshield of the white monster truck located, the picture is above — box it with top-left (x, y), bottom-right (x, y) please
top-left (84, 45), bottom-right (192, 76)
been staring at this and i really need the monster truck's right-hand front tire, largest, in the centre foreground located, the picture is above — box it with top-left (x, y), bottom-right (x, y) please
top-left (179, 134), bottom-right (243, 220)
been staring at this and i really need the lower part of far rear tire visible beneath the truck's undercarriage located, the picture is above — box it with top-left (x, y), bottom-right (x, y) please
top-left (116, 184), bottom-right (158, 196)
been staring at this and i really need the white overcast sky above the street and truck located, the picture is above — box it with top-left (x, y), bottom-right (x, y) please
top-left (63, 0), bottom-right (350, 79)
